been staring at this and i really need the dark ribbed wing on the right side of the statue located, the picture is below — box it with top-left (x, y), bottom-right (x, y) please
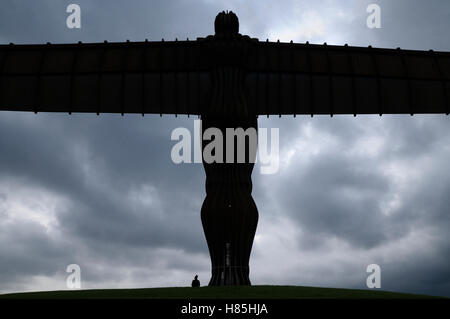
top-left (245, 42), bottom-right (450, 116)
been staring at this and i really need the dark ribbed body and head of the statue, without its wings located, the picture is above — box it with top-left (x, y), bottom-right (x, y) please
top-left (201, 12), bottom-right (258, 286)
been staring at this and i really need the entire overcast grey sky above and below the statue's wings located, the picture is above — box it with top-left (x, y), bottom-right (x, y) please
top-left (0, 0), bottom-right (450, 296)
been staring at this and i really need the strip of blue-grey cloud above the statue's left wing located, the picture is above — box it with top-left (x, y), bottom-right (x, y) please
top-left (0, 0), bottom-right (218, 43)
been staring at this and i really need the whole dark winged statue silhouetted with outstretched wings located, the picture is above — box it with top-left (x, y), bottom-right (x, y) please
top-left (0, 11), bottom-right (450, 287)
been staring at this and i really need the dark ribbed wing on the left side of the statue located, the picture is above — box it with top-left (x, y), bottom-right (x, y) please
top-left (0, 41), bottom-right (210, 115)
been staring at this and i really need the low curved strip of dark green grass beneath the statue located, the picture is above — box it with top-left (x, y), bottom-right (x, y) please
top-left (0, 286), bottom-right (439, 299)
